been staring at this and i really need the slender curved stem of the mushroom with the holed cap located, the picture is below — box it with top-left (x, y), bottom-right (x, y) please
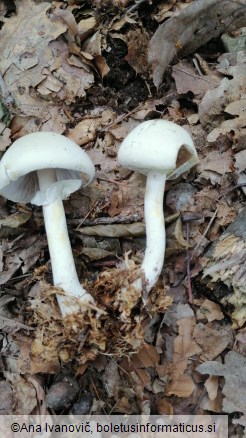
top-left (141, 171), bottom-right (166, 292)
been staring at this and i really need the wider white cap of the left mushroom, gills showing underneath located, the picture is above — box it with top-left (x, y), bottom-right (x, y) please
top-left (0, 132), bottom-right (95, 205)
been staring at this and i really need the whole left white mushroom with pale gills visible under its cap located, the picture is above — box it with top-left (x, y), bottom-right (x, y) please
top-left (0, 132), bottom-right (95, 317)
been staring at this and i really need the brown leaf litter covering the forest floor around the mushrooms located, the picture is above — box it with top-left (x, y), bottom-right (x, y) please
top-left (0, 0), bottom-right (246, 436)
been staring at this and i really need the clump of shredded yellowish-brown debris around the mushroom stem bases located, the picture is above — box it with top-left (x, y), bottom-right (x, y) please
top-left (21, 263), bottom-right (171, 372)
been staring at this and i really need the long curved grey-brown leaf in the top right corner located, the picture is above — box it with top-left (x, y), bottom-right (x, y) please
top-left (149, 0), bottom-right (246, 87)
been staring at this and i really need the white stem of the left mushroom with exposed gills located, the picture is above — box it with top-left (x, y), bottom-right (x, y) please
top-left (37, 169), bottom-right (93, 317)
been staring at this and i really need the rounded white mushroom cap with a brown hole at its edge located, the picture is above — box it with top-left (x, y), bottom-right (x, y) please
top-left (118, 119), bottom-right (199, 179)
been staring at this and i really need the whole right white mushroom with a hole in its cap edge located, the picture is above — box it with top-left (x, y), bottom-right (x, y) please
top-left (118, 119), bottom-right (198, 292)
